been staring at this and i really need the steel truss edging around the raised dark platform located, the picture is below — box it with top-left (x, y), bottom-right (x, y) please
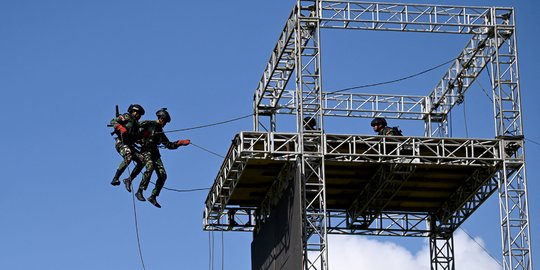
top-left (204, 132), bottom-right (503, 226)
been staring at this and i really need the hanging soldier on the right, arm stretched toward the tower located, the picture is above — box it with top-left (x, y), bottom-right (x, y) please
top-left (124, 108), bottom-right (190, 208)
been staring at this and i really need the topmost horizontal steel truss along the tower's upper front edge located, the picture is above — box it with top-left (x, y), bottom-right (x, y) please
top-left (321, 0), bottom-right (512, 34)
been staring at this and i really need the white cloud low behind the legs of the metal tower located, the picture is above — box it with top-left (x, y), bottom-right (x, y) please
top-left (328, 232), bottom-right (501, 270)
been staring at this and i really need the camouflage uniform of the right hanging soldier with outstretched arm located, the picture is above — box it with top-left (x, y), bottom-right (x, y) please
top-left (139, 121), bottom-right (179, 197)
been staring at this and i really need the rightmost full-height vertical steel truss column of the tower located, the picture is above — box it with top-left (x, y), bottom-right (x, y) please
top-left (491, 8), bottom-right (533, 270)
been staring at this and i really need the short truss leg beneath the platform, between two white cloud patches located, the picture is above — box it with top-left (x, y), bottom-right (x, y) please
top-left (429, 233), bottom-right (456, 270)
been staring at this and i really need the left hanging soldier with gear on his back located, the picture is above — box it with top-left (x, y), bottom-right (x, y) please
top-left (111, 104), bottom-right (144, 186)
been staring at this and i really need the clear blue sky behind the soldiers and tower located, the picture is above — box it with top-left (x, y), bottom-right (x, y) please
top-left (0, 0), bottom-right (540, 269)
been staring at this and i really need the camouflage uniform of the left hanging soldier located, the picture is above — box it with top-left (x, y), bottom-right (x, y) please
top-left (111, 113), bottom-right (144, 184)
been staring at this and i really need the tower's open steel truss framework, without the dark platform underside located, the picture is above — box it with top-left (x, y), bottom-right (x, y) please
top-left (213, 0), bottom-right (532, 270)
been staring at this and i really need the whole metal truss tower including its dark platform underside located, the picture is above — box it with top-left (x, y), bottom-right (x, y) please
top-left (204, 0), bottom-right (532, 270)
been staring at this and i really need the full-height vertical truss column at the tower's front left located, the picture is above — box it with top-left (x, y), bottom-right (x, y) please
top-left (295, 0), bottom-right (328, 270)
